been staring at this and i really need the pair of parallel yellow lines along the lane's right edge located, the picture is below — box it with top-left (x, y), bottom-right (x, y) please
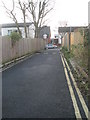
top-left (61, 55), bottom-right (89, 120)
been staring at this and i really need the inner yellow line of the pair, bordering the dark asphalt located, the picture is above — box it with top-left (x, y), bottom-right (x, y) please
top-left (61, 56), bottom-right (82, 120)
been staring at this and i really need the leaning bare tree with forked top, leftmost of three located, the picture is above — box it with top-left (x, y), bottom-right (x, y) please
top-left (2, 0), bottom-right (21, 36)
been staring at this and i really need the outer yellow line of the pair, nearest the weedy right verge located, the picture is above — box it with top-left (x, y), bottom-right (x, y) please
top-left (64, 58), bottom-right (89, 118)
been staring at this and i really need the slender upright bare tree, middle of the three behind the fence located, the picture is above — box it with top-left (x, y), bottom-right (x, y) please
top-left (18, 0), bottom-right (27, 38)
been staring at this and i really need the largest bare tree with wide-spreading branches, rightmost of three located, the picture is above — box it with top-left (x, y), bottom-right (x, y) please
top-left (28, 0), bottom-right (53, 38)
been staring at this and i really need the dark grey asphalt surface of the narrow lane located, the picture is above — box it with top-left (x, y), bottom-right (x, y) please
top-left (2, 49), bottom-right (75, 118)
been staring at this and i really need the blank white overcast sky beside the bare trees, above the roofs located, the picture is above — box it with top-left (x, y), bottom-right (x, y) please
top-left (0, 0), bottom-right (90, 35)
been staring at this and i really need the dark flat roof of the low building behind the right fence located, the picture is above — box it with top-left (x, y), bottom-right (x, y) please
top-left (58, 26), bottom-right (87, 33)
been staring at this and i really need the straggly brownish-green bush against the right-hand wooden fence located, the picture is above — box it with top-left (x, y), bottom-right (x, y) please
top-left (62, 44), bottom-right (88, 71)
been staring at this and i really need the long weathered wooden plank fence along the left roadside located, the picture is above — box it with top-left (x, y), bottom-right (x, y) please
top-left (0, 36), bottom-right (45, 64)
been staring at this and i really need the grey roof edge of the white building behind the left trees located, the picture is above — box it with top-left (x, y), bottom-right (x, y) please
top-left (0, 22), bottom-right (33, 28)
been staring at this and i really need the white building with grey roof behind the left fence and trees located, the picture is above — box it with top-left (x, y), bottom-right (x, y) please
top-left (0, 23), bottom-right (34, 38)
